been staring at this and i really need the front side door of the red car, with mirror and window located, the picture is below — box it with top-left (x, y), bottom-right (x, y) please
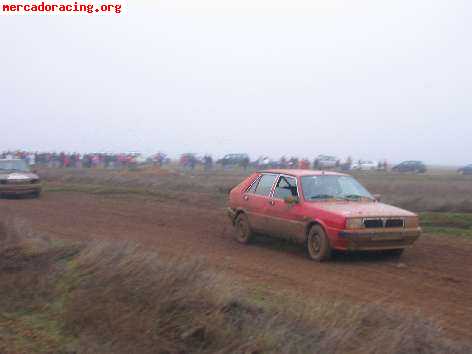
top-left (266, 175), bottom-right (305, 240)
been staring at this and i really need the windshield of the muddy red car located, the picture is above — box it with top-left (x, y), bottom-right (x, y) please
top-left (301, 175), bottom-right (374, 201)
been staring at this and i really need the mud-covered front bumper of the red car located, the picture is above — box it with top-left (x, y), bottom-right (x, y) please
top-left (338, 227), bottom-right (421, 251)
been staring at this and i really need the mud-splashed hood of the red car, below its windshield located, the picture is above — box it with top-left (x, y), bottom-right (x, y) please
top-left (307, 201), bottom-right (416, 217)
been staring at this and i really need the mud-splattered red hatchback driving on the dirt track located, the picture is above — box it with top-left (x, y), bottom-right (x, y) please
top-left (227, 170), bottom-right (421, 261)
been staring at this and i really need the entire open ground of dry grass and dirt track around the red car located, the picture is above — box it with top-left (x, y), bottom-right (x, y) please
top-left (0, 168), bottom-right (472, 353)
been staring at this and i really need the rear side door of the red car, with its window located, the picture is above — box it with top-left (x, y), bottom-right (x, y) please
top-left (243, 173), bottom-right (277, 233)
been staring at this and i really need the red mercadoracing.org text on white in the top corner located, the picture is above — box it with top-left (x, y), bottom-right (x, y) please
top-left (0, 1), bottom-right (122, 15)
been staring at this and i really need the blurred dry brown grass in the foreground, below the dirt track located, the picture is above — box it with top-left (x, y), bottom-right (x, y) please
top-left (0, 219), bottom-right (471, 354)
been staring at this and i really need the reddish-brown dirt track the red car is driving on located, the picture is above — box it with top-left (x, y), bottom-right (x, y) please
top-left (0, 192), bottom-right (472, 341)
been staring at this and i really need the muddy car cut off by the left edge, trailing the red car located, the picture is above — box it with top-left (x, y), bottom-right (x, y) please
top-left (0, 159), bottom-right (41, 197)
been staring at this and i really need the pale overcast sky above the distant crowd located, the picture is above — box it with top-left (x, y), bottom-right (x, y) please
top-left (0, 0), bottom-right (472, 164)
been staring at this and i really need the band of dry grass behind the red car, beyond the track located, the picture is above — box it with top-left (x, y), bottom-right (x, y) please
top-left (41, 169), bottom-right (472, 213)
